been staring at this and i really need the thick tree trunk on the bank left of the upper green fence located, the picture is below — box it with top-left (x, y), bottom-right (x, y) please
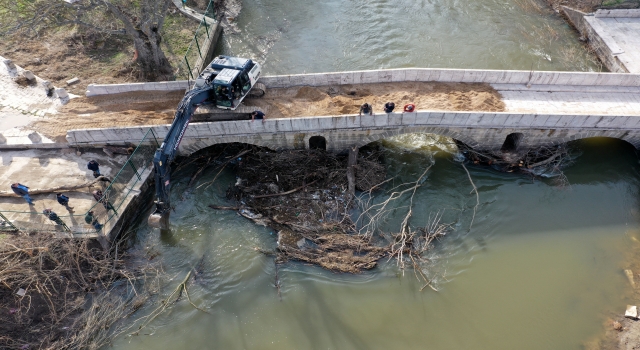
top-left (133, 29), bottom-right (173, 81)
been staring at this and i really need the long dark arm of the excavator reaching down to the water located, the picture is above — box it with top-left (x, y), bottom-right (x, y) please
top-left (148, 85), bottom-right (215, 229)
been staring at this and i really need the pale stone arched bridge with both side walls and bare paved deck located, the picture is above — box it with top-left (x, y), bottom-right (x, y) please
top-left (67, 69), bottom-right (640, 154)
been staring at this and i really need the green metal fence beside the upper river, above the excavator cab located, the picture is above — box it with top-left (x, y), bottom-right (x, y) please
top-left (180, 0), bottom-right (215, 85)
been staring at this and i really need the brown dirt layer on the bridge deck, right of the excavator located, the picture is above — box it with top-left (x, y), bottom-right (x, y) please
top-left (246, 82), bottom-right (505, 118)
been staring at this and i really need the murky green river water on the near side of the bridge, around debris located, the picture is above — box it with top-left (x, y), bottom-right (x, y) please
top-left (115, 135), bottom-right (640, 349)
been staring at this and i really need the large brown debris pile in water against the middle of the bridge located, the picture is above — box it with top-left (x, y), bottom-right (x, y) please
top-left (211, 149), bottom-right (389, 273)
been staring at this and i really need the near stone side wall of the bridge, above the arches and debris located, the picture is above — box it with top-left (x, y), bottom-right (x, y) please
top-left (67, 111), bottom-right (640, 155)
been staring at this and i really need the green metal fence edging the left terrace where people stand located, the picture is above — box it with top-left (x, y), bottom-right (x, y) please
top-left (0, 129), bottom-right (159, 234)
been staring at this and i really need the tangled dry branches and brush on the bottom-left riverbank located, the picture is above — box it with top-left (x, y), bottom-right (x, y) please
top-left (0, 233), bottom-right (159, 349)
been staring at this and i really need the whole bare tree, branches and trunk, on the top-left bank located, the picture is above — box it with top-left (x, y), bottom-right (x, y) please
top-left (0, 0), bottom-right (173, 81)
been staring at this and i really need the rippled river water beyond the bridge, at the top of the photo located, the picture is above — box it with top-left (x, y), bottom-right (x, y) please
top-left (217, 0), bottom-right (600, 75)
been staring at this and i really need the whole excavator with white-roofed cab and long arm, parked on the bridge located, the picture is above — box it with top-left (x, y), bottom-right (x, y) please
top-left (148, 55), bottom-right (266, 229)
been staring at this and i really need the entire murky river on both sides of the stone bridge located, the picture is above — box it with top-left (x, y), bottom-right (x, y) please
top-left (107, 0), bottom-right (640, 349)
